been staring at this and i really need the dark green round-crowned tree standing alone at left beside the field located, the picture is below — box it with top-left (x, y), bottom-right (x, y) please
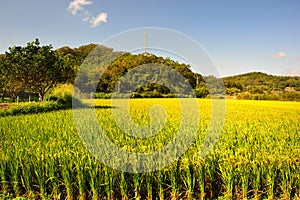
top-left (6, 39), bottom-right (71, 101)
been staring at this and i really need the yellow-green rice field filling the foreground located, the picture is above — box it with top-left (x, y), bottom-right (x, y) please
top-left (0, 99), bottom-right (300, 200)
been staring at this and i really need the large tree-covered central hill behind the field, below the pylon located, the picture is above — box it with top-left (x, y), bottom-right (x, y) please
top-left (56, 44), bottom-right (208, 97)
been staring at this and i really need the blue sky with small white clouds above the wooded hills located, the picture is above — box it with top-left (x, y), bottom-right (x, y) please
top-left (0, 0), bottom-right (300, 76)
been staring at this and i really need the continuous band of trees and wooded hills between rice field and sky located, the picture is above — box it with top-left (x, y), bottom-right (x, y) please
top-left (0, 39), bottom-right (300, 101)
